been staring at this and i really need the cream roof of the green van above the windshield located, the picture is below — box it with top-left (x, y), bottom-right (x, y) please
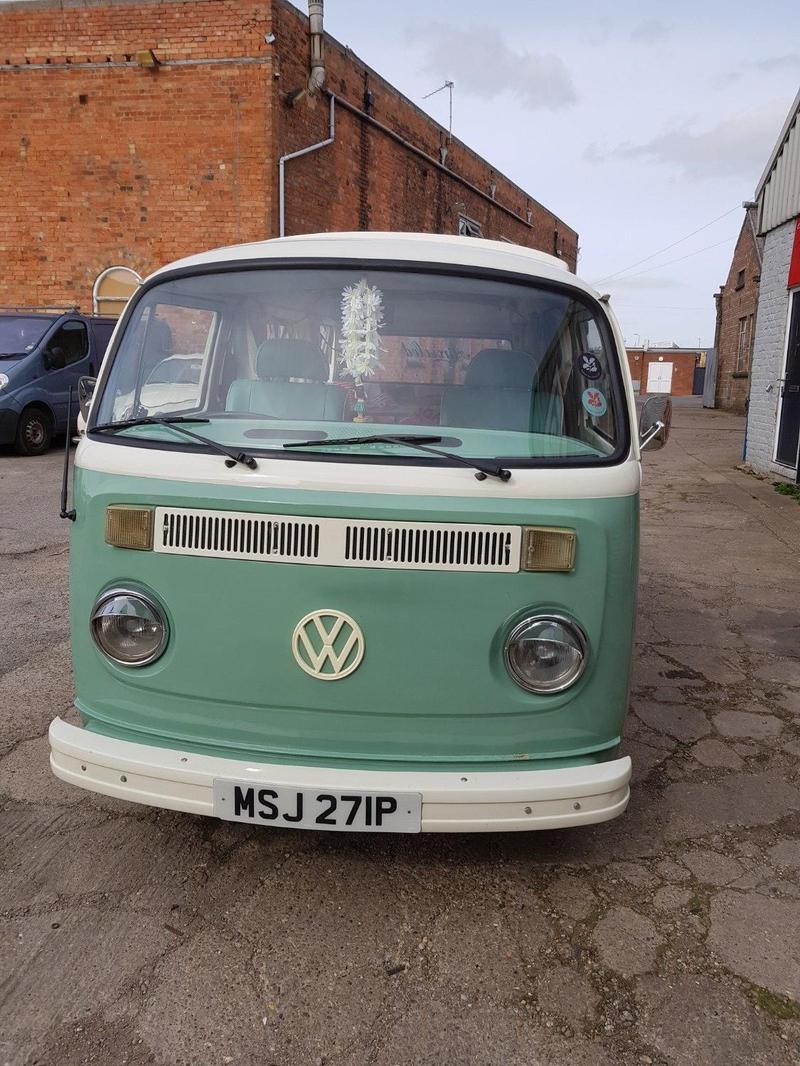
top-left (151, 231), bottom-right (596, 295)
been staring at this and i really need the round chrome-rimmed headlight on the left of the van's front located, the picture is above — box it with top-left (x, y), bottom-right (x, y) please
top-left (92, 588), bottom-right (170, 666)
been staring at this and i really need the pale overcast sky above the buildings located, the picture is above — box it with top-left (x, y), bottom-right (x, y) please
top-left (322, 0), bottom-right (800, 345)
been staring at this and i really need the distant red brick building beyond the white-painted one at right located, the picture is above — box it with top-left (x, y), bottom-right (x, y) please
top-left (715, 211), bottom-right (761, 415)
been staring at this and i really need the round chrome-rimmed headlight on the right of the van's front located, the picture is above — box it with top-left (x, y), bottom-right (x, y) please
top-left (506, 615), bottom-right (587, 693)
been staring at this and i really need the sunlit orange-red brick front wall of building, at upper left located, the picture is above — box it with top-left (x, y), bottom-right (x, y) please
top-left (0, 0), bottom-right (272, 308)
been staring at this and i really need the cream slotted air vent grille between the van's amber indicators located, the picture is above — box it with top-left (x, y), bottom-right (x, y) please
top-left (154, 507), bottom-right (522, 574)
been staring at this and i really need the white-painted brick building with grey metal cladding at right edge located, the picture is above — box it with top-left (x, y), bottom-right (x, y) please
top-left (745, 93), bottom-right (800, 480)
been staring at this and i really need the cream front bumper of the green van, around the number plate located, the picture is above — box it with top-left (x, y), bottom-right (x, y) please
top-left (49, 718), bottom-right (631, 833)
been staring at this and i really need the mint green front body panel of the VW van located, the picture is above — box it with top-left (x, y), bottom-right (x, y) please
top-left (70, 469), bottom-right (639, 771)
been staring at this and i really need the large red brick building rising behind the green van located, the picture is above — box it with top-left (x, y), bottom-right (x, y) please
top-left (0, 0), bottom-right (577, 308)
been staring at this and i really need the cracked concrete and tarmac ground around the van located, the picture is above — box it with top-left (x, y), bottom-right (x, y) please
top-left (0, 407), bottom-right (800, 1066)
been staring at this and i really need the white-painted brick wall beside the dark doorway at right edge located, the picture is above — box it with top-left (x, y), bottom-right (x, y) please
top-left (746, 219), bottom-right (795, 473)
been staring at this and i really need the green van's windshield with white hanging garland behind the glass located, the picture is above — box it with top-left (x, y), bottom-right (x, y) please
top-left (94, 265), bottom-right (625, 463)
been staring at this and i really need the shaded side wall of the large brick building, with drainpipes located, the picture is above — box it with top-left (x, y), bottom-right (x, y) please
top-left (273, 0), bottom-right (578, 270)
